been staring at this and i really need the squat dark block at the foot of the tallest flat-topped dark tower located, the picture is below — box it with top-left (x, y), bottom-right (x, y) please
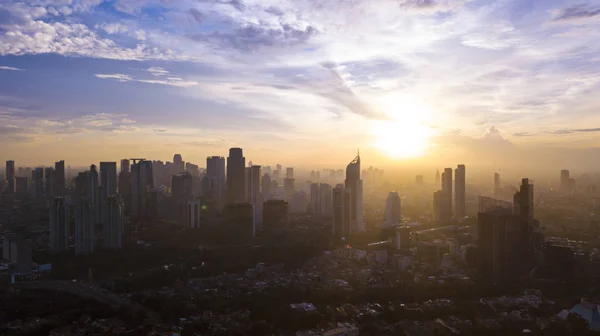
top-left (224, 203), bottom-right (256, 244)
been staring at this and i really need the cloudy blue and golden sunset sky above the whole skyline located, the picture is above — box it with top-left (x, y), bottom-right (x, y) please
top-left (0, 0), bottom-right (600, 169)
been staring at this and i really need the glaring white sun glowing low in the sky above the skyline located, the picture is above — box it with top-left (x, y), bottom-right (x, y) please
top-left (372, 97), bottom-right (433, 159)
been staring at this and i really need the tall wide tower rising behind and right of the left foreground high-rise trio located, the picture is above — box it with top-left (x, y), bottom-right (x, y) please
top-left (130, 159), bottom-right (154, 217)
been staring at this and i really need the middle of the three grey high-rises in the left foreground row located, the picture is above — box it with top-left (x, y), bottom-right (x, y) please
top-left (75, 197), bottom-right (95, 255)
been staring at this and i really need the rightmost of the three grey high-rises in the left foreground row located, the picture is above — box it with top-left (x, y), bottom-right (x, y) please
top-left (102, 194), bottom-right (125, 250)
